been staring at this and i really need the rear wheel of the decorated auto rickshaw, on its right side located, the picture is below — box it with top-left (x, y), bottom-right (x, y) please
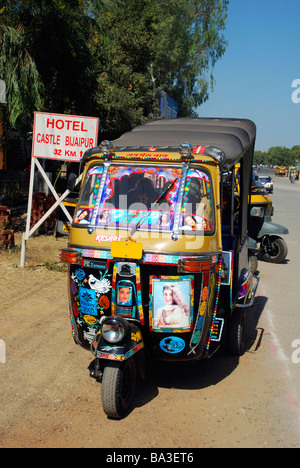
top-left (228, 308), bottom-right (247, 356)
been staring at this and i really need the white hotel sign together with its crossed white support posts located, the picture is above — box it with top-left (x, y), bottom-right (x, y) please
top-left (20, 112), bottom-right (98, 267)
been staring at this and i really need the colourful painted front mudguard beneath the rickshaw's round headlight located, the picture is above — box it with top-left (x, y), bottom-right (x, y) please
top-left (94, 323), bottom-right (144, 363)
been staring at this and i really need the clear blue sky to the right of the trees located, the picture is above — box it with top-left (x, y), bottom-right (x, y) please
top-left (197, 0), bottom-right (300, 151)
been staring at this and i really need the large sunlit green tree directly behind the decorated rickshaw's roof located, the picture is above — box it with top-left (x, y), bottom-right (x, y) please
top-left (91, 0), bottom-right (228, 134)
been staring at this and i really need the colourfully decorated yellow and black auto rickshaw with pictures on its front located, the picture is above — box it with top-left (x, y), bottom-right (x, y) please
top-left (62, 118), bottom-right (259, 419)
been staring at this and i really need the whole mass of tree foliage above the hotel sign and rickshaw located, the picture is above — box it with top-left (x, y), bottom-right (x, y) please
top-left (0, 0), bottom-right (228, 137)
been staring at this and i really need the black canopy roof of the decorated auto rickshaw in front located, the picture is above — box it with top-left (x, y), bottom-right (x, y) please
top-left (112, 118), bottom-right (256, 168)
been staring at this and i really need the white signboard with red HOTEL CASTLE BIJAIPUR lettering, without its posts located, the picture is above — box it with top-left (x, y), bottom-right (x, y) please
top-left (32, 112), bottom-right (99, 162)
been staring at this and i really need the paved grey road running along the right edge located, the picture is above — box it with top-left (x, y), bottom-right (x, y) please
top-left (254, 170), bottom-right (300, 438)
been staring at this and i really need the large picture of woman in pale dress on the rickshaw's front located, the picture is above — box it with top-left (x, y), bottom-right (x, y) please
top-left (152, 277), bottom-right (191, 330)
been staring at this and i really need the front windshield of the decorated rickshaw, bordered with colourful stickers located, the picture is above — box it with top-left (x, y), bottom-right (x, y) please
top-left (74, 164), bottom-right (214, 233)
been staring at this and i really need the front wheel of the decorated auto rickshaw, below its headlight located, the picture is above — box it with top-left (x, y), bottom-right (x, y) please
top-left (101, 358), bottom-right (136, 419)
